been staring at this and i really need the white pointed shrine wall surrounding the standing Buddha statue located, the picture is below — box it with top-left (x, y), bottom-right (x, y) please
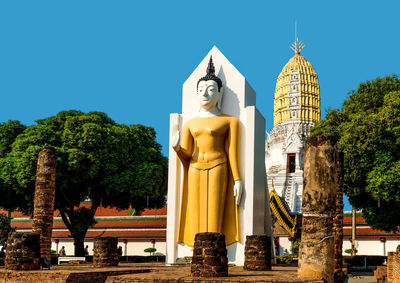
top-left (166, 46), bottom-right (271, 265)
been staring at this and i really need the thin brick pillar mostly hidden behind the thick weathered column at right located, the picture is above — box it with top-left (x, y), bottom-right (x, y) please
top-left (333, 152), bottom-right (345, 282)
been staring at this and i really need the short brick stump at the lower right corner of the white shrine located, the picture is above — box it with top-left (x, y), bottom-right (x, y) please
top-left (243, 235), bottom-right (271, 270)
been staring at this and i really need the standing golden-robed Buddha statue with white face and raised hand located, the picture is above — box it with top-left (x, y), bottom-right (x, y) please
top-left (172, 58), bottom-right (243, 246)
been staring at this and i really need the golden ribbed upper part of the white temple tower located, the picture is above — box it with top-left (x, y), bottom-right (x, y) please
top-left (274, 38), bottom-right (321, 126)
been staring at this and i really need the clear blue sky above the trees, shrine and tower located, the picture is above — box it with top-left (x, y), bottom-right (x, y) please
top-left (0, 0), bottom-right (400, 212)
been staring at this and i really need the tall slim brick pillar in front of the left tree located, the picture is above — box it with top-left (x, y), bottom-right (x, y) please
top-left (32, 146), bottom-right (56, 262)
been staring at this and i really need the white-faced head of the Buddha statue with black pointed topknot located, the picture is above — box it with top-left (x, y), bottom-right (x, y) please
top-left (197, 57), bottom-right (224, 110)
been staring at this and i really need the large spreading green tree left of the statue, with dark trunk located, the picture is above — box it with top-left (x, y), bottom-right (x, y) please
top-left (0, 110), bottom-right (167, 256)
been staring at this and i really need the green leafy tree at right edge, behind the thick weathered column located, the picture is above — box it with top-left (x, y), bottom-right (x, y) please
top-left (311, 75), bottom-right (400, 231)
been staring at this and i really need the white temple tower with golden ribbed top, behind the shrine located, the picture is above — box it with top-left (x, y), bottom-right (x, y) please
top-left (265, 39), bottom-right (321, 214)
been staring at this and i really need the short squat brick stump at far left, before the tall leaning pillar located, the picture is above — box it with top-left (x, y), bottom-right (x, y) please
top-left (5, 232), bottom-right (40, 270)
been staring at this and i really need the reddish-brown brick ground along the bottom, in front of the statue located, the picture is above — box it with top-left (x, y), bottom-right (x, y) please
top-left (0, 263), bottom-right (323, 283)
